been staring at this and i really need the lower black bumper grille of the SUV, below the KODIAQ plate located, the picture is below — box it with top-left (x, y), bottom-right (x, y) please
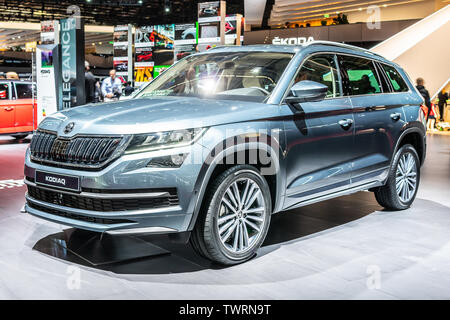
top-left (28, 185), bottom-right (178, 212)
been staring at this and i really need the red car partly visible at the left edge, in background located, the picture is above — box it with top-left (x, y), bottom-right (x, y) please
top-left (0, 80), bottom-right (37, 139)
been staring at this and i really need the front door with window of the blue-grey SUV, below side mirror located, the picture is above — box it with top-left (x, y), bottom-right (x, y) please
top-left (281, 54), bottom-right (353, 208)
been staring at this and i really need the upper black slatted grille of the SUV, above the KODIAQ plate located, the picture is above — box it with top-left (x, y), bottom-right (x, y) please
top-left (30, 131), bottom-right (122, 169)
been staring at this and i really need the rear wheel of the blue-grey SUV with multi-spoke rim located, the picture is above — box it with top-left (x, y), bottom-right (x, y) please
top-left (375, 144), bottom-right (420, 210)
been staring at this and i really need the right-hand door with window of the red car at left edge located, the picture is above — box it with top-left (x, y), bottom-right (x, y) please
top-left (14, 82), bottom-right (34, 132)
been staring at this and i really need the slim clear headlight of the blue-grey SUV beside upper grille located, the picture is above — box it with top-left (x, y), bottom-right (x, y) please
top-left (125, 128), bottom-right (206, 154)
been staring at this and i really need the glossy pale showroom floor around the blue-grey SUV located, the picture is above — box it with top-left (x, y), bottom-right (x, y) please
top-left (0, 135), bottom-right (450, 299)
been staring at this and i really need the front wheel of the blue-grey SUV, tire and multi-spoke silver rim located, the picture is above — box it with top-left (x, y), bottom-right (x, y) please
top-left (190, 165), bottom-right (272, 265)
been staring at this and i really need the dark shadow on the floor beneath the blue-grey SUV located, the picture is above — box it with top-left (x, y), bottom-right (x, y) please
top-left (33, 192), bottom-right (382, 274)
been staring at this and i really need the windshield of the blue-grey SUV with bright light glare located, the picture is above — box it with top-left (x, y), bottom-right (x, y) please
top-left (136, 52), bottom-right (293, 101)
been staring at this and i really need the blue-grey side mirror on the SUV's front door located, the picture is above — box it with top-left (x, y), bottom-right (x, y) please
top-left (286, 80), bottom-right (328, 105)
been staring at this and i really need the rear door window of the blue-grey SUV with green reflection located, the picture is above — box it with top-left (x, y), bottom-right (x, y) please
top-left (341, 56), bottom-right (381, 95)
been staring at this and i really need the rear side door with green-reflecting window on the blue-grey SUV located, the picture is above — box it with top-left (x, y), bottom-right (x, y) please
top-left (339, 55), bottom-right (405, 184)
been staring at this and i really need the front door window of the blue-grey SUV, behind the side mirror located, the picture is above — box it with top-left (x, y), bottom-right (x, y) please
top-left (295, 54), bottom-right (341, 98)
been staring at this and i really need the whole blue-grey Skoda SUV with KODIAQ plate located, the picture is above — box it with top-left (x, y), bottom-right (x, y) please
top-left (25, 42), bottom-right (426, 264)
